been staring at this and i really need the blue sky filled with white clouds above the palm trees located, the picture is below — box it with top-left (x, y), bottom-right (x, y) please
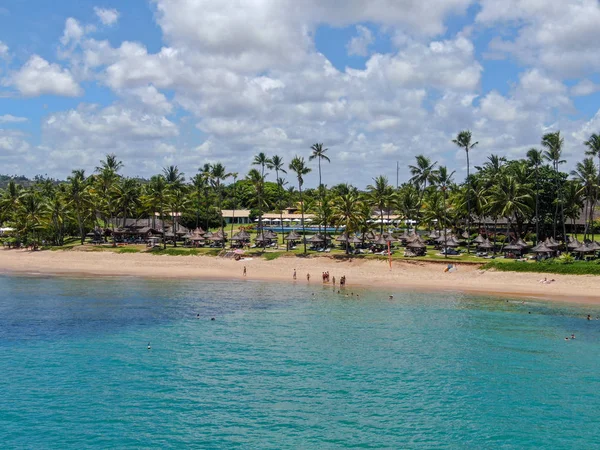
top-left (0, 0), bottom-right (600, 187)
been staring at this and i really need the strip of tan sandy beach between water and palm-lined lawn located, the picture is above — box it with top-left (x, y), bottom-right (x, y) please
top-left (0, 250), bottom-right (600, 305)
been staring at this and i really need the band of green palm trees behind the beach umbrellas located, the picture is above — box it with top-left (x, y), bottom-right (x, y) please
top-left (0, 131), bottom-right (600, 251)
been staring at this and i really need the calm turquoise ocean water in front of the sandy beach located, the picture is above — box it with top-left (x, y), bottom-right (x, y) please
top-left (0, 277), bottom-right (600, 449)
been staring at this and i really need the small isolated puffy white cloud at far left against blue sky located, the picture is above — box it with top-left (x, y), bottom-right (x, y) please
top-left (9, 55), bottom-right (83, 97)
